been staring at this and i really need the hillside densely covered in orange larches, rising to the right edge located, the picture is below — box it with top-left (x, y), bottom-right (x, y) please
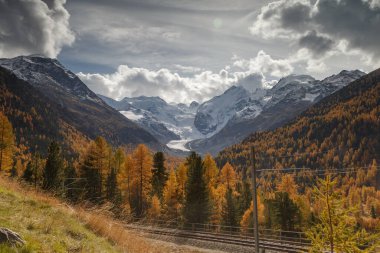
top-left (217, 69), bottom-right (380, 173)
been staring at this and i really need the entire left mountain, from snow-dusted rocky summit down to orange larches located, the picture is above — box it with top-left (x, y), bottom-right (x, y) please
top-left (0, 55), bottom-right (163, 153)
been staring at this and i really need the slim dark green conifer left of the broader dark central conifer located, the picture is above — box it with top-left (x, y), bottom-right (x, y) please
top-left (152, 152), bottom-right (168, 199)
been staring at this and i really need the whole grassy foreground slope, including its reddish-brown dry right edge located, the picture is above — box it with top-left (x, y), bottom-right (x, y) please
top-left (0, 177), bottom-right (206, 253)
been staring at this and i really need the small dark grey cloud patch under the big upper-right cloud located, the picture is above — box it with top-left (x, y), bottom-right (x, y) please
top-left (298, 30), bottom-right (334, 56)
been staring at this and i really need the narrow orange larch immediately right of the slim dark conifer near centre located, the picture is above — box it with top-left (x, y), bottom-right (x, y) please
top-left (163, 170), bottom-right (180, 220)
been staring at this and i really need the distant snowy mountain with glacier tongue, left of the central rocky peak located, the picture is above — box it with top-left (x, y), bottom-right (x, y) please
top-left (98, 95), bottom-right (201, 149)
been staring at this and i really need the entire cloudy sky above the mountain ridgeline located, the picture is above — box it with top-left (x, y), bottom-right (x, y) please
top-left (0, 0), bottom-right (380, 103)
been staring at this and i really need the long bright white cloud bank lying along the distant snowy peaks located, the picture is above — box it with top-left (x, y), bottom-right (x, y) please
top-left (77, 51), bottom-right (293, 103)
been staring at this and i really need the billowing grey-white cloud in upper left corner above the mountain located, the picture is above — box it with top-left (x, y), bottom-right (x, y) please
top-left (0, 0), bottom-right (75, 57)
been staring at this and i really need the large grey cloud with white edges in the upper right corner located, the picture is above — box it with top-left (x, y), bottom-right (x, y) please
top-left (250, 0), bottom-right (380, 61)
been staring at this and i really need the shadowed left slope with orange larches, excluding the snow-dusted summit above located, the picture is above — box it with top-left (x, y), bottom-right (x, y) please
top-left (0, 67), bottom-right (162, 155)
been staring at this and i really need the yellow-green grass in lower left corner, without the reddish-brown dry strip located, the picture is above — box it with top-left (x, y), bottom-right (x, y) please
top-left (0, 181), bottom-right (121, 253)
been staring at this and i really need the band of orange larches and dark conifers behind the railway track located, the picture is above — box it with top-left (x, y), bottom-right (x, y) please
top-left (0, 113), bottom-right (380, 252)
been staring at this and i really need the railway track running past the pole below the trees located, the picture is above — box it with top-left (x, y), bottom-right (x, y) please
top-left (127, 224), bottom-right (309, 253)
